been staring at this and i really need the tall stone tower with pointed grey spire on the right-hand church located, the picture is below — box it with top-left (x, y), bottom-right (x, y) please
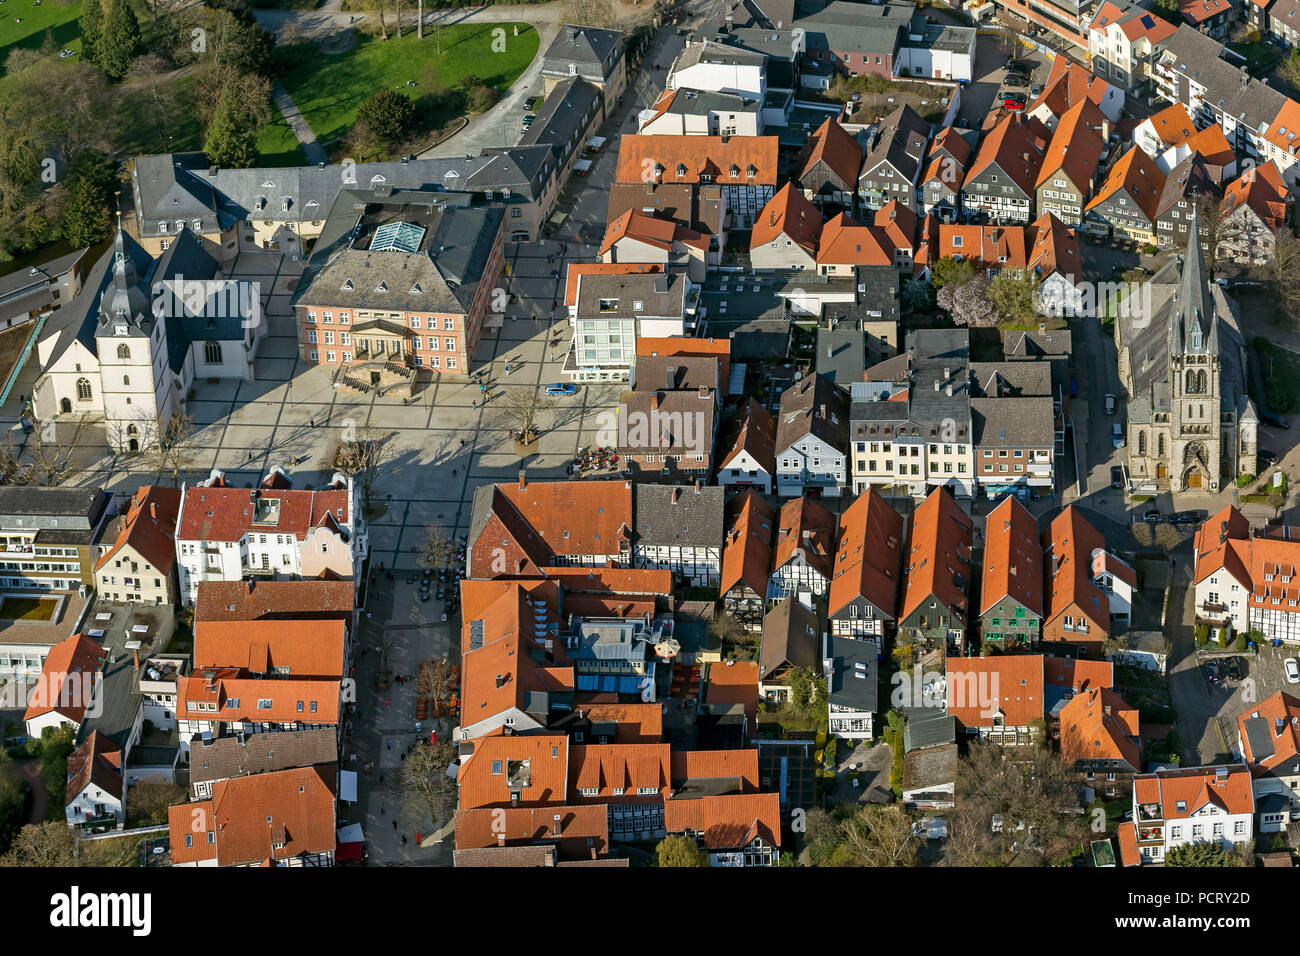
top-left (1169, 211), bottom-right (1222, 492)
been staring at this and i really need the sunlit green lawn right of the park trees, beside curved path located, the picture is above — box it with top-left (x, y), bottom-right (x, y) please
top-left (280, 23), bottom-right (538, 143)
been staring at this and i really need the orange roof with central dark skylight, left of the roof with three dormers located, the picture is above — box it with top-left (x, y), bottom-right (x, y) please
top-left (456, 734), bottom-right (572, 810)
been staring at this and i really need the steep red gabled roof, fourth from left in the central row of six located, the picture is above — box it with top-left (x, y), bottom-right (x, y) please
top-left (898, 488), bottom-right (971, 620)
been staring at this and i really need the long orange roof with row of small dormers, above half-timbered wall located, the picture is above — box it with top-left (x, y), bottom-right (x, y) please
top-left (614, 135), bottom-right (777, 189)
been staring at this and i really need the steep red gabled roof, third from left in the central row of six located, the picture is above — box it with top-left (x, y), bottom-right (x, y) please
top-left (827, 486), bottom-right (902, 620)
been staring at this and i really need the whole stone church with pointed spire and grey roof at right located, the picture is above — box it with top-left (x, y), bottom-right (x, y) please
top-left (1115, 210), bottom-right (1258, 492)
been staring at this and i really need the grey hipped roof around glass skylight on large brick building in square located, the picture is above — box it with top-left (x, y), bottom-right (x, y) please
top-left (294, 190), bottom-right (504, 314)
